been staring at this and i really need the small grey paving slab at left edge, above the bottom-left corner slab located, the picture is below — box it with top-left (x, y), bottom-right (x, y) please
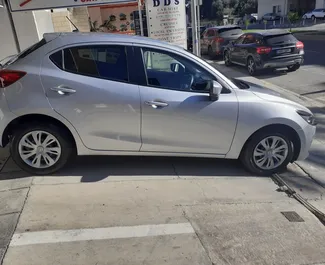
top-left (0, 188), bottom-right (28, 215)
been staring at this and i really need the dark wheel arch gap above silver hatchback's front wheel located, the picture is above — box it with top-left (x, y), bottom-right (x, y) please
top-left (240, 124), bottom-right (301, 162)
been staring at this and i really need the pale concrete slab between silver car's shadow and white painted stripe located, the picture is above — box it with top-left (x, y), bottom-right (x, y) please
top-left (17, 178), bottom-right (288, 233)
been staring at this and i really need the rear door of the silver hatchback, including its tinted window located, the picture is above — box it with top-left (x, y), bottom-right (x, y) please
top-left (39, 44), bottom-right (141, 151)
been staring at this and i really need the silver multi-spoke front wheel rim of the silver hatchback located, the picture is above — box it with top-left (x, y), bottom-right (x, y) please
top-left (253, 136), bottom-right (289, 170)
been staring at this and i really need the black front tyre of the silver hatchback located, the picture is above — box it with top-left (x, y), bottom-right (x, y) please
top-left (240, 130), bottom-right (293, 176)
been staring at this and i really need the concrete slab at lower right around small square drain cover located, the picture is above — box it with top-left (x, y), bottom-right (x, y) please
top-left (185, 200), bottom-right (325, 265)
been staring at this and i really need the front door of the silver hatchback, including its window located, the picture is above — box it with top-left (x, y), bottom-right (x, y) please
top-left (137, 47), bottom-right (238, 156)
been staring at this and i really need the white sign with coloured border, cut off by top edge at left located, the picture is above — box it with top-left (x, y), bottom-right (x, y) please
top-left (9, 0), bottom-right (136, 12)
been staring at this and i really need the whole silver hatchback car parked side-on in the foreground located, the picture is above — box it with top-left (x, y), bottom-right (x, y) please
top-left (0, 33), bottom-right (315, 174)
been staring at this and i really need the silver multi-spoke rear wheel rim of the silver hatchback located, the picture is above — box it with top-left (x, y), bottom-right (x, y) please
top-left (18, 131), bottom-right (62, 169)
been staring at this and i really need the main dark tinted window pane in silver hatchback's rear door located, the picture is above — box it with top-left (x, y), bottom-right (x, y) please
top-left (64, 46), bottom-right (129, 81)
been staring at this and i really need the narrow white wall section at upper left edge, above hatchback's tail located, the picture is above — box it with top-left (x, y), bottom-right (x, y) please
top-left (0, 8), bottom-right (17, 60)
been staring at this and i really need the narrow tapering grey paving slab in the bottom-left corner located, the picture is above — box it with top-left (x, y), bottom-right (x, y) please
top-left (0, 213), bottom-right (19, 264)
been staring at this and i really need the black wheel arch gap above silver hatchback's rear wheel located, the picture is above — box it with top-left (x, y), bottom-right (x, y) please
top-left (1, 114), bottom-right (77, 148)
